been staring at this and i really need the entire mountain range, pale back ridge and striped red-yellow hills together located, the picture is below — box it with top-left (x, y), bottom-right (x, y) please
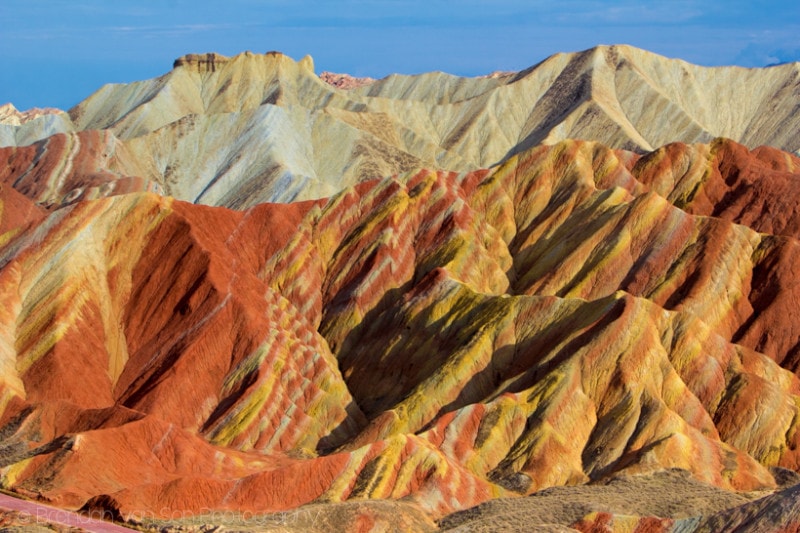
top-left (0, 46), bottom-right (800, 532)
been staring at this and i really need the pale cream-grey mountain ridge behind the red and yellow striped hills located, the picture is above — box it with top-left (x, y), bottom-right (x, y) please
top-left (0, 45), bottom-right (800, 209)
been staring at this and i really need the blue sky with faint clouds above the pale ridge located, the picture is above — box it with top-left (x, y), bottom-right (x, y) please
top-left (0, 0), bottom-right (800, 109)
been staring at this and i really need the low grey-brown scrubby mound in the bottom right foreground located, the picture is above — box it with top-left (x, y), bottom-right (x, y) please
top-left (439, 471), bottom-right (800, 533)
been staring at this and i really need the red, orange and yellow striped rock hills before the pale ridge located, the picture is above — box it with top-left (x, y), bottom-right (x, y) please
top-left (0, 140), bottom-right (800, 518)
